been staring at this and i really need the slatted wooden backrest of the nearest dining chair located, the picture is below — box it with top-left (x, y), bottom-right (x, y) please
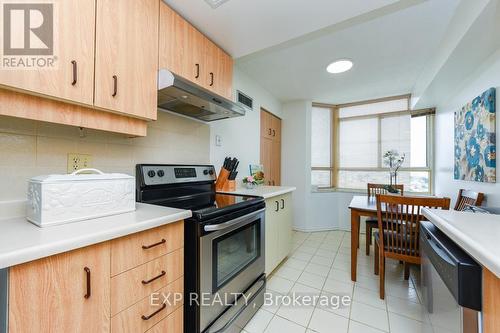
top-left (377, 194), bottom-right (450, 257)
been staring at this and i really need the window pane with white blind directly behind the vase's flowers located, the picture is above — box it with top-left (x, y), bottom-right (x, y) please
top-left (380, 114), bottom-right (412, 168)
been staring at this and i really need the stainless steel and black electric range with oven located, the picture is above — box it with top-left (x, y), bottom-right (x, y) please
top-left (136, 164), bottom-right (266, 333)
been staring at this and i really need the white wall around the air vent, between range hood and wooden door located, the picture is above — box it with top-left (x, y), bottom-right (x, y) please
top-left (210, 66), bottom-right (282, 179)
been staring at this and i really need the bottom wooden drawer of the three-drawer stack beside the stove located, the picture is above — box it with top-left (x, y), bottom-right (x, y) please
top-left (111, 277), bottom-right (184, 333)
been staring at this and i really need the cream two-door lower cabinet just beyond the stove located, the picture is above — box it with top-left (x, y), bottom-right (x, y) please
top-left (265, 193), bottom-right (293, 274)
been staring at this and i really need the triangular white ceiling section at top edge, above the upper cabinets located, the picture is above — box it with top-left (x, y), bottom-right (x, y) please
top-left (164, 0), bottom-right (398, 58)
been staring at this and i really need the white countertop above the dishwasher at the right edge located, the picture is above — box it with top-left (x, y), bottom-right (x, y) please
top-left (422, 208), bottom-right (500, 278)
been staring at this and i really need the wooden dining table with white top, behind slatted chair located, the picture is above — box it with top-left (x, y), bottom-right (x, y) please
top-left (349, 195), bottom-right (377, 281)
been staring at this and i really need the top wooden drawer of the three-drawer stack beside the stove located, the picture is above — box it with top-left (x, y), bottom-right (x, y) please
top-left (111, 221), bottom-right (184, 276)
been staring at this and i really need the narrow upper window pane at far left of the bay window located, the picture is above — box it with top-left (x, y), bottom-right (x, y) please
top-left (311, 107), bottom-right (332, 167)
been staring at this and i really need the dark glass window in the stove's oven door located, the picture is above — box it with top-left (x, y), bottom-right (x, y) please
top-left (212, 220), bottom-right (260, 291)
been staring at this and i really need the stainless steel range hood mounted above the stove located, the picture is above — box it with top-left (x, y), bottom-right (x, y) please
top-left (158, 69), bottom-right (246, 122)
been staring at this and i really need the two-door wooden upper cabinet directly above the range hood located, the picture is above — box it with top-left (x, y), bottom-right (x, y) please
top-left (158, 0), bottom-right (233, 99)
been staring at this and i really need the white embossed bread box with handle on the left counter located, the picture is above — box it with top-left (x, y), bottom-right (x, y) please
top-left (27, 169), bottom-right (135, 227)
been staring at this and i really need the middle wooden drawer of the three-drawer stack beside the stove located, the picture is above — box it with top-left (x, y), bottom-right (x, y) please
top-left (111, 248), bottom-right (184, 316)
